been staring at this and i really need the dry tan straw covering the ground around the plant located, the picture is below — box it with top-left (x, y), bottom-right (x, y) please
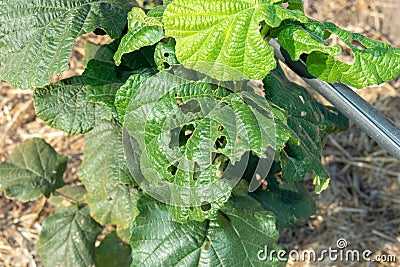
top-left (0, 0), bottom-right (400, 267)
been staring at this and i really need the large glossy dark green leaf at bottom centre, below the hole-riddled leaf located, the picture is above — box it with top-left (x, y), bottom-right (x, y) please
top-left (130, 196), bottom-right (284, 266)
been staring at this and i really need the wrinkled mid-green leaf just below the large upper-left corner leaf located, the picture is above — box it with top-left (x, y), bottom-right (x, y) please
top-left (33, 77), bottom-right (110, 135)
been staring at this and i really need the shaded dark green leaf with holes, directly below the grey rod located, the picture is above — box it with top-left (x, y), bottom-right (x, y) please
top-left (264, 68), bottom-right (348, 193)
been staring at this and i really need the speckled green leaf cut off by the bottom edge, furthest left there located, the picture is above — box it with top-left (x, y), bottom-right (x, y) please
top-left (36, 206), bottom-right (102, 267)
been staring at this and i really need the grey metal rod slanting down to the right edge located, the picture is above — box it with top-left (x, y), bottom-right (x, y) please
top-left (269, 39), bottom-right (400, 160)
